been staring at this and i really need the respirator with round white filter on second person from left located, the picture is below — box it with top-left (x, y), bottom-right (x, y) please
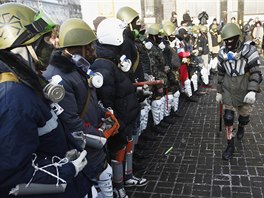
top-left (72, 54), bottom-right (104, 88)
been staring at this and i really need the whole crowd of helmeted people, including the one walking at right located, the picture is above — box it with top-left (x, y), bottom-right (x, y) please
top-left (0, 3), bottom-right (262, 198)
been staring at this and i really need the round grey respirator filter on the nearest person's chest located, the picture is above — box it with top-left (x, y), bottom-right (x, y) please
top-left (43, 75), bottom-right (65, 103)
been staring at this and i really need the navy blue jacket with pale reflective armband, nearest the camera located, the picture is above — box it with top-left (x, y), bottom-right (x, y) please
top-left (0, 56), bottom-right (89, 198)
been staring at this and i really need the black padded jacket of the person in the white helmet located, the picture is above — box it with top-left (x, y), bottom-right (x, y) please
top-left (91, 43), bottom-right (140, 150)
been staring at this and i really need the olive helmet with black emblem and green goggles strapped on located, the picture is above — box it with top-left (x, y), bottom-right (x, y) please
top-left (0, 3), bottom-right (55, 49)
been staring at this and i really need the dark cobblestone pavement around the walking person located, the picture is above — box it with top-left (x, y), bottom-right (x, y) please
top-left (126, 68), bottom-right (264, 198)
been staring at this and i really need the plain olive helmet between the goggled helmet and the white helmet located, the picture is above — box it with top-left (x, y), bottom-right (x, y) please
top-left (59, 19), bottom-right (96, 48)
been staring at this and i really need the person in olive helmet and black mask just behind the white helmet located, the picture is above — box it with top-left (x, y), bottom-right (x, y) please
top-left (116, 6), bottom-right (155, 171)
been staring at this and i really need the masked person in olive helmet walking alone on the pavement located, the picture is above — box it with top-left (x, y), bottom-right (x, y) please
top-left (216, 23), bottom-right (262, 160)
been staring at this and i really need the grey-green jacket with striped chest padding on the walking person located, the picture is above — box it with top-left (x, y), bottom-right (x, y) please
top-left (217, 41), bottom-right (262, 106)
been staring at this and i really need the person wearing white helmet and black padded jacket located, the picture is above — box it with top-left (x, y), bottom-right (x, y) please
top-left (91, 18), bottom-right (147, 198)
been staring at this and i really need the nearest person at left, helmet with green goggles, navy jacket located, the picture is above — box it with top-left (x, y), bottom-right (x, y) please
top-left (0, 3), bottom-right (91, 198)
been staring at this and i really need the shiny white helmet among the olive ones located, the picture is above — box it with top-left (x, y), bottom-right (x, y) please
top-left (97, 18), bottom-right (126, 46)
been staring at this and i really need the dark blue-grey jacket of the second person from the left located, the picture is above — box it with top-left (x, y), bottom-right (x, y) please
top-left (43, 50), bottom-right (106, 179)
